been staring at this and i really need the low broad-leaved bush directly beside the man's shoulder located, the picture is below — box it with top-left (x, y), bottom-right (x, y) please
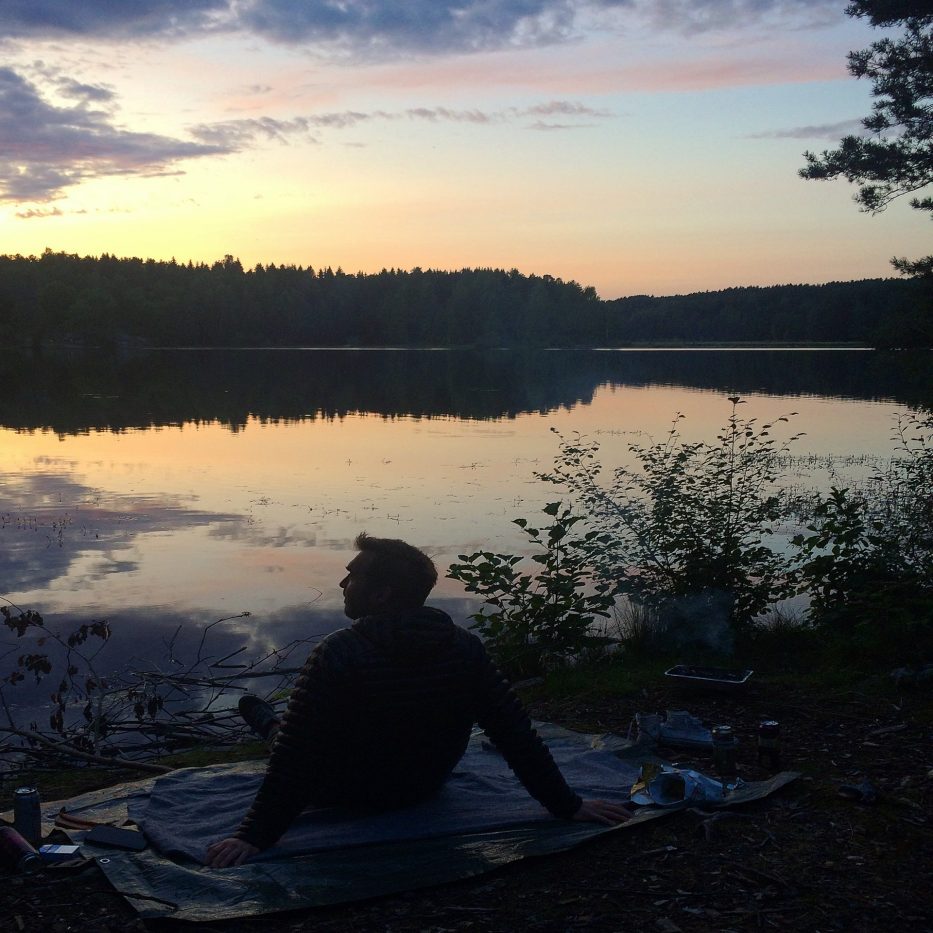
top-left (447, 502), bottom-right (613, 678)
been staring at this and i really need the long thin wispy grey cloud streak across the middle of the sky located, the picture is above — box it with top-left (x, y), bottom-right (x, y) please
top-left (190, 100), bottom-right (612, 149)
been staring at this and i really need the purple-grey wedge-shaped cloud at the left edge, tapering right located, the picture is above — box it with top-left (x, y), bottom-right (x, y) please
top-left (0, 68), bottom-right (230, 201)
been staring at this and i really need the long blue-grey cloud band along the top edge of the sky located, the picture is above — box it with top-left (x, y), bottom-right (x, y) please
top-left (0, 0), bottom-right (842, 59)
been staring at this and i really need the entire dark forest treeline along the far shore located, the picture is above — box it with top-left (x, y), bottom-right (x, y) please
top-left (0, 250), bottom-right (933, 347)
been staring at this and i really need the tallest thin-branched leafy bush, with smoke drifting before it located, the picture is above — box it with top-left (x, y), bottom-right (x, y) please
top-left (541, 398), bottom-right (800, 638)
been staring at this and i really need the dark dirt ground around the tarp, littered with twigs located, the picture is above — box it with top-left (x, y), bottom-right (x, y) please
top-left (0, 680), bottom-right (933, 933)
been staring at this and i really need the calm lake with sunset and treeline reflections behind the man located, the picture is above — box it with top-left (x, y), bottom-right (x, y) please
top-left (0, 349), bottom-right (933, 696)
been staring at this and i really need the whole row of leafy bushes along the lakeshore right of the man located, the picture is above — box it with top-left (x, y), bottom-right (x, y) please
top-left (448, 398), bottom-right (933, 676)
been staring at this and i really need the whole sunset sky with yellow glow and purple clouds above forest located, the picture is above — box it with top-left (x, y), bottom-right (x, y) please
top-left (0, 0), bottom-right (930, 298)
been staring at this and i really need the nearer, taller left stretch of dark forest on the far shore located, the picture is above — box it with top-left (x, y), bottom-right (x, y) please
top-left (0, 250), bottom-right (602, 347)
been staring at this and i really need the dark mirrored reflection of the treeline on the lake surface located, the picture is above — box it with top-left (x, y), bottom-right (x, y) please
top-left (0, 349), bottom-right (933, 434)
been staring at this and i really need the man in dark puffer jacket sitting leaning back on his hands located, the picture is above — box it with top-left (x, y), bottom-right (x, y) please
top-left (207, 533), bottom-right (630, 868)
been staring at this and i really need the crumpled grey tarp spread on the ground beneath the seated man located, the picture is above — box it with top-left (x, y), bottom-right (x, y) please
top-left (31, 725), bottom-right (797, 921)
